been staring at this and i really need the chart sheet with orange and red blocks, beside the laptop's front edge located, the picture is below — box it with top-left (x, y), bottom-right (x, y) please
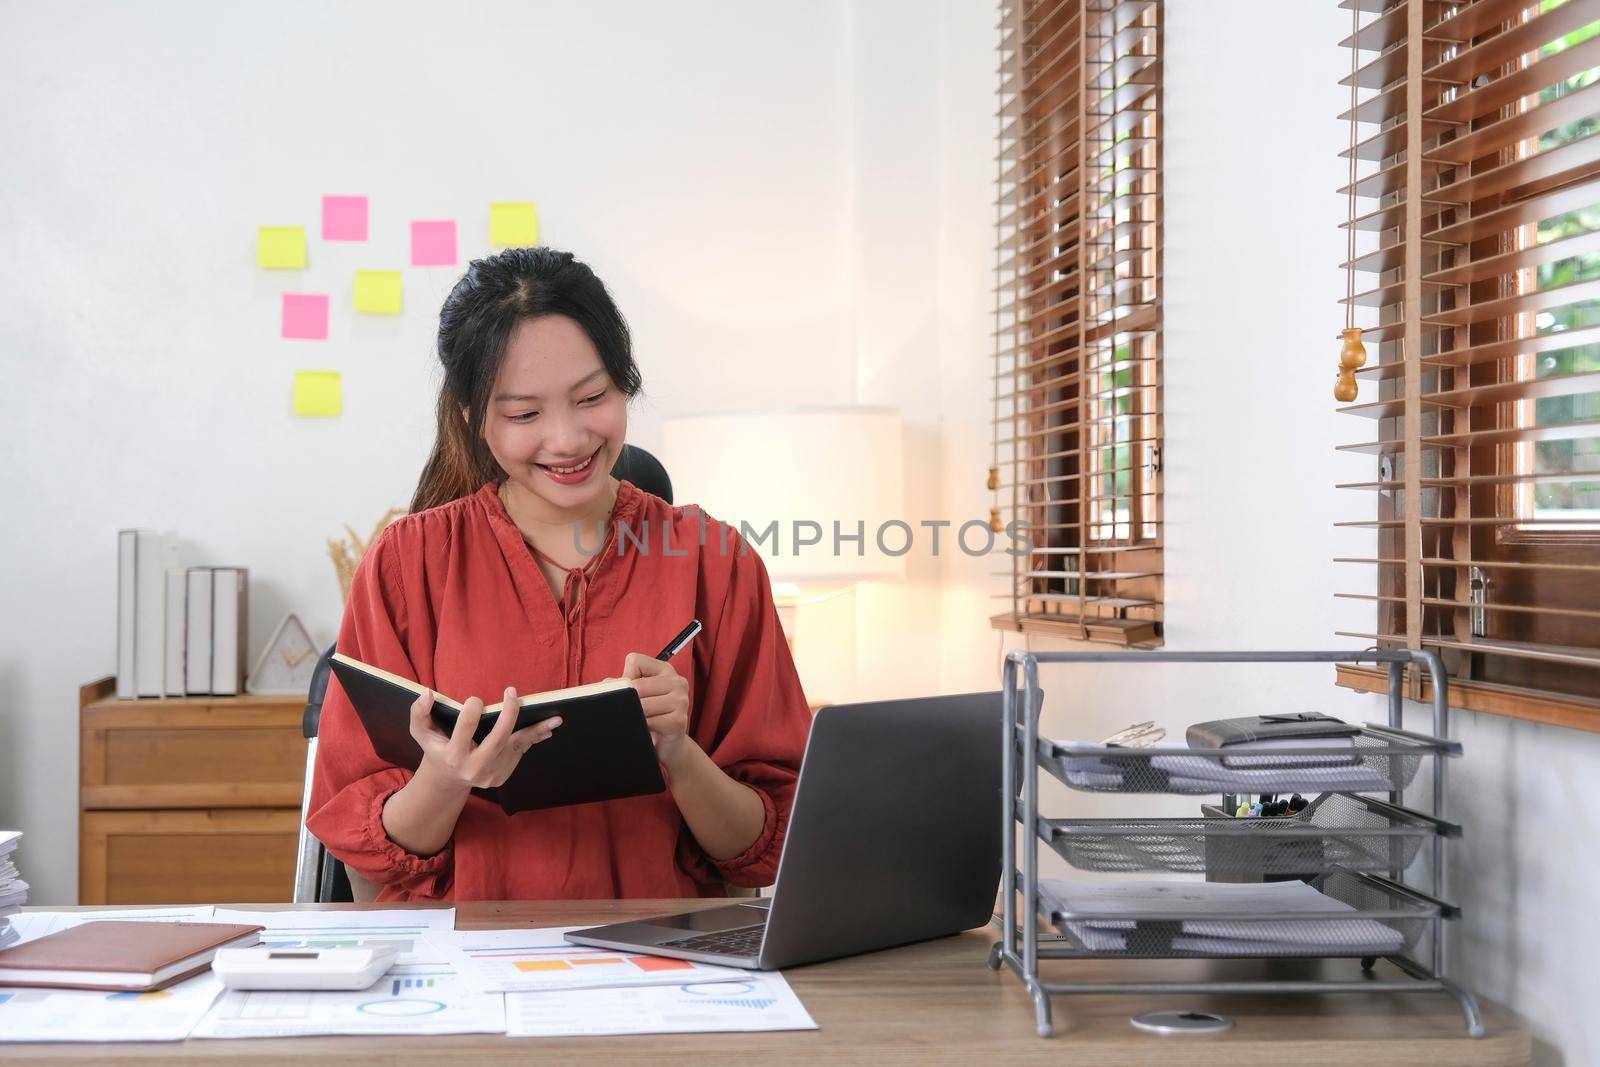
top-left (427, 926), bottom-right (750, 993)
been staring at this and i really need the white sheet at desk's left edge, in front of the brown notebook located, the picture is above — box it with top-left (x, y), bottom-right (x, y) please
top-left (0, 971), bottom-right (222, 1041)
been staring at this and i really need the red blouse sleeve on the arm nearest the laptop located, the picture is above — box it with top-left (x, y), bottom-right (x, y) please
top-left (693, 536), bottom-right (811, 886)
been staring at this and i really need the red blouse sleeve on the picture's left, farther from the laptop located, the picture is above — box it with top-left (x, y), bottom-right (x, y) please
top-left (306, 531), bottom-right (453, 901)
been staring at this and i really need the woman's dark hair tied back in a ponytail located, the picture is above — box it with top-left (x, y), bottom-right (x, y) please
top-left (411, 248), bottom-right (642, 512)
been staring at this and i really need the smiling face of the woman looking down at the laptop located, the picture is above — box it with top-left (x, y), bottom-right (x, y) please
top-left (483, 315), bottom-right (627, 514)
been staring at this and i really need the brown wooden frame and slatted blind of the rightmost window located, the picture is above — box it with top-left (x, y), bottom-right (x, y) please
top-left (1339, 5), bottom-right (1600, 731)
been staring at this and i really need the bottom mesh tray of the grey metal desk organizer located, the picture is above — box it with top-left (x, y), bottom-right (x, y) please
top-left (1038, 872), bottom-right (1456, 960)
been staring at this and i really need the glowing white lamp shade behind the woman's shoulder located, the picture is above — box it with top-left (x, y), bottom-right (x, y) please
top-left (661, 406), bottom-right (925, 582)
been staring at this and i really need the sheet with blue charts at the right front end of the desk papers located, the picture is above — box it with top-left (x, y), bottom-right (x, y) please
top-left (506, 971), bottom-right (816, 1037)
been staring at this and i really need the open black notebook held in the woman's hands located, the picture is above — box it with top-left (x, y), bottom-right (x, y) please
top-left (333, 653), bottom-right (667, 814)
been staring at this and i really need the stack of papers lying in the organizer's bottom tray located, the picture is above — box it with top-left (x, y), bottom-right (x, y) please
top-left (1038, 878), bottom-right (1405, 957)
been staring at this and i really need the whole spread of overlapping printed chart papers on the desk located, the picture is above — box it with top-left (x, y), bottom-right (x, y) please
top-left (0, 907), bottom-right (816, 1043)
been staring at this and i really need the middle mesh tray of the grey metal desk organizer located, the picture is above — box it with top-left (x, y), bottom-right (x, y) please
top-left (1040, 793), bottom-right (1459, 875)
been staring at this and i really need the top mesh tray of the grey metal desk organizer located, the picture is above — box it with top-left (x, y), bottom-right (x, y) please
top-left (1038, 726), bottom-right (1461, 795)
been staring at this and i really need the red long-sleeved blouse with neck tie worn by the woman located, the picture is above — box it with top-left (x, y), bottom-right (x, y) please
top-left (307, 482), bottom-right (811, 901)
